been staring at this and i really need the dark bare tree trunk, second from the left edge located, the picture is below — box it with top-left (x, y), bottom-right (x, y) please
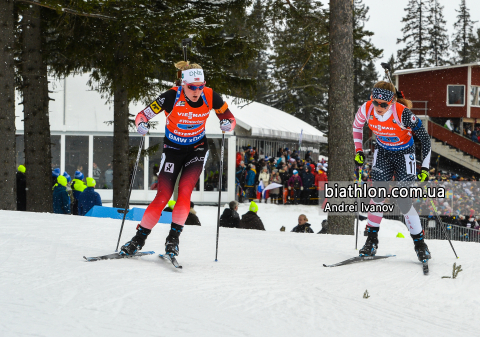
top-left (19, 5), bottom-right (53, 212)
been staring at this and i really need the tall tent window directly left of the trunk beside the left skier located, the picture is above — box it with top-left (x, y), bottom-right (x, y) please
top-left (93, 136), bottom-right (113, 189)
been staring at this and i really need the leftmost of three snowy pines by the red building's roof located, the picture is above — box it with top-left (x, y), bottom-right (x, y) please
top-left (397, 0), bottom-right (430, 69)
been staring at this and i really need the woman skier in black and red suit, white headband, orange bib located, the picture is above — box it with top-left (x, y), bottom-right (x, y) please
top-left (121, 61), bottom-right (236, 256)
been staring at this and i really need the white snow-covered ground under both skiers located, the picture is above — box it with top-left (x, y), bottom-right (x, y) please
top-left (0, 204), bottom-right (480, 337)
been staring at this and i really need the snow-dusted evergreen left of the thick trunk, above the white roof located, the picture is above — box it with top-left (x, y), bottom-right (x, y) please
top-left (266, 1), bottom-right (328, 133)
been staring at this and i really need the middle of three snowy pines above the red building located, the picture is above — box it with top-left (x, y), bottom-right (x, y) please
top-left (427, 0), bottom-right (449, 66)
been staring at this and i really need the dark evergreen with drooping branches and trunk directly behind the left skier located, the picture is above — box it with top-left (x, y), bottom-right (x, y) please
top-left (47, 0), bottom-right (255, 207)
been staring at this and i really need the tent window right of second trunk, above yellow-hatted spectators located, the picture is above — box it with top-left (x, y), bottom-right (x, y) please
top-left (64, 136), bottom-right (88, 179)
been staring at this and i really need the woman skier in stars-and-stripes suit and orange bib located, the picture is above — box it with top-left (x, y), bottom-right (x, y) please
top-left (353, 81), bottom-right (431, 263)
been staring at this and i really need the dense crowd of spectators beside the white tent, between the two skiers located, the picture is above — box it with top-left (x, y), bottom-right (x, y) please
top-left (235, 146), bottom-right (328, 205)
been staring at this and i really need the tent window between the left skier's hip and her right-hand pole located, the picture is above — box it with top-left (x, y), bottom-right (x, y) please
top-left (204, 138), bottom-right (228, 191)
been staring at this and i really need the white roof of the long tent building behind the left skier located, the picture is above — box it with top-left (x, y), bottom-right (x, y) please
top-left (16, 74), bottom-right (327, 143)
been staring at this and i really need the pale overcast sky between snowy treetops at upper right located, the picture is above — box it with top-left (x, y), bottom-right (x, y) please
top-left (363, 0), bottom-right (480, 76)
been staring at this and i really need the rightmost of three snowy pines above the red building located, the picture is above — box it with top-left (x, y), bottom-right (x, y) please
top-left (452, 0), bottom-right (477, 64)
